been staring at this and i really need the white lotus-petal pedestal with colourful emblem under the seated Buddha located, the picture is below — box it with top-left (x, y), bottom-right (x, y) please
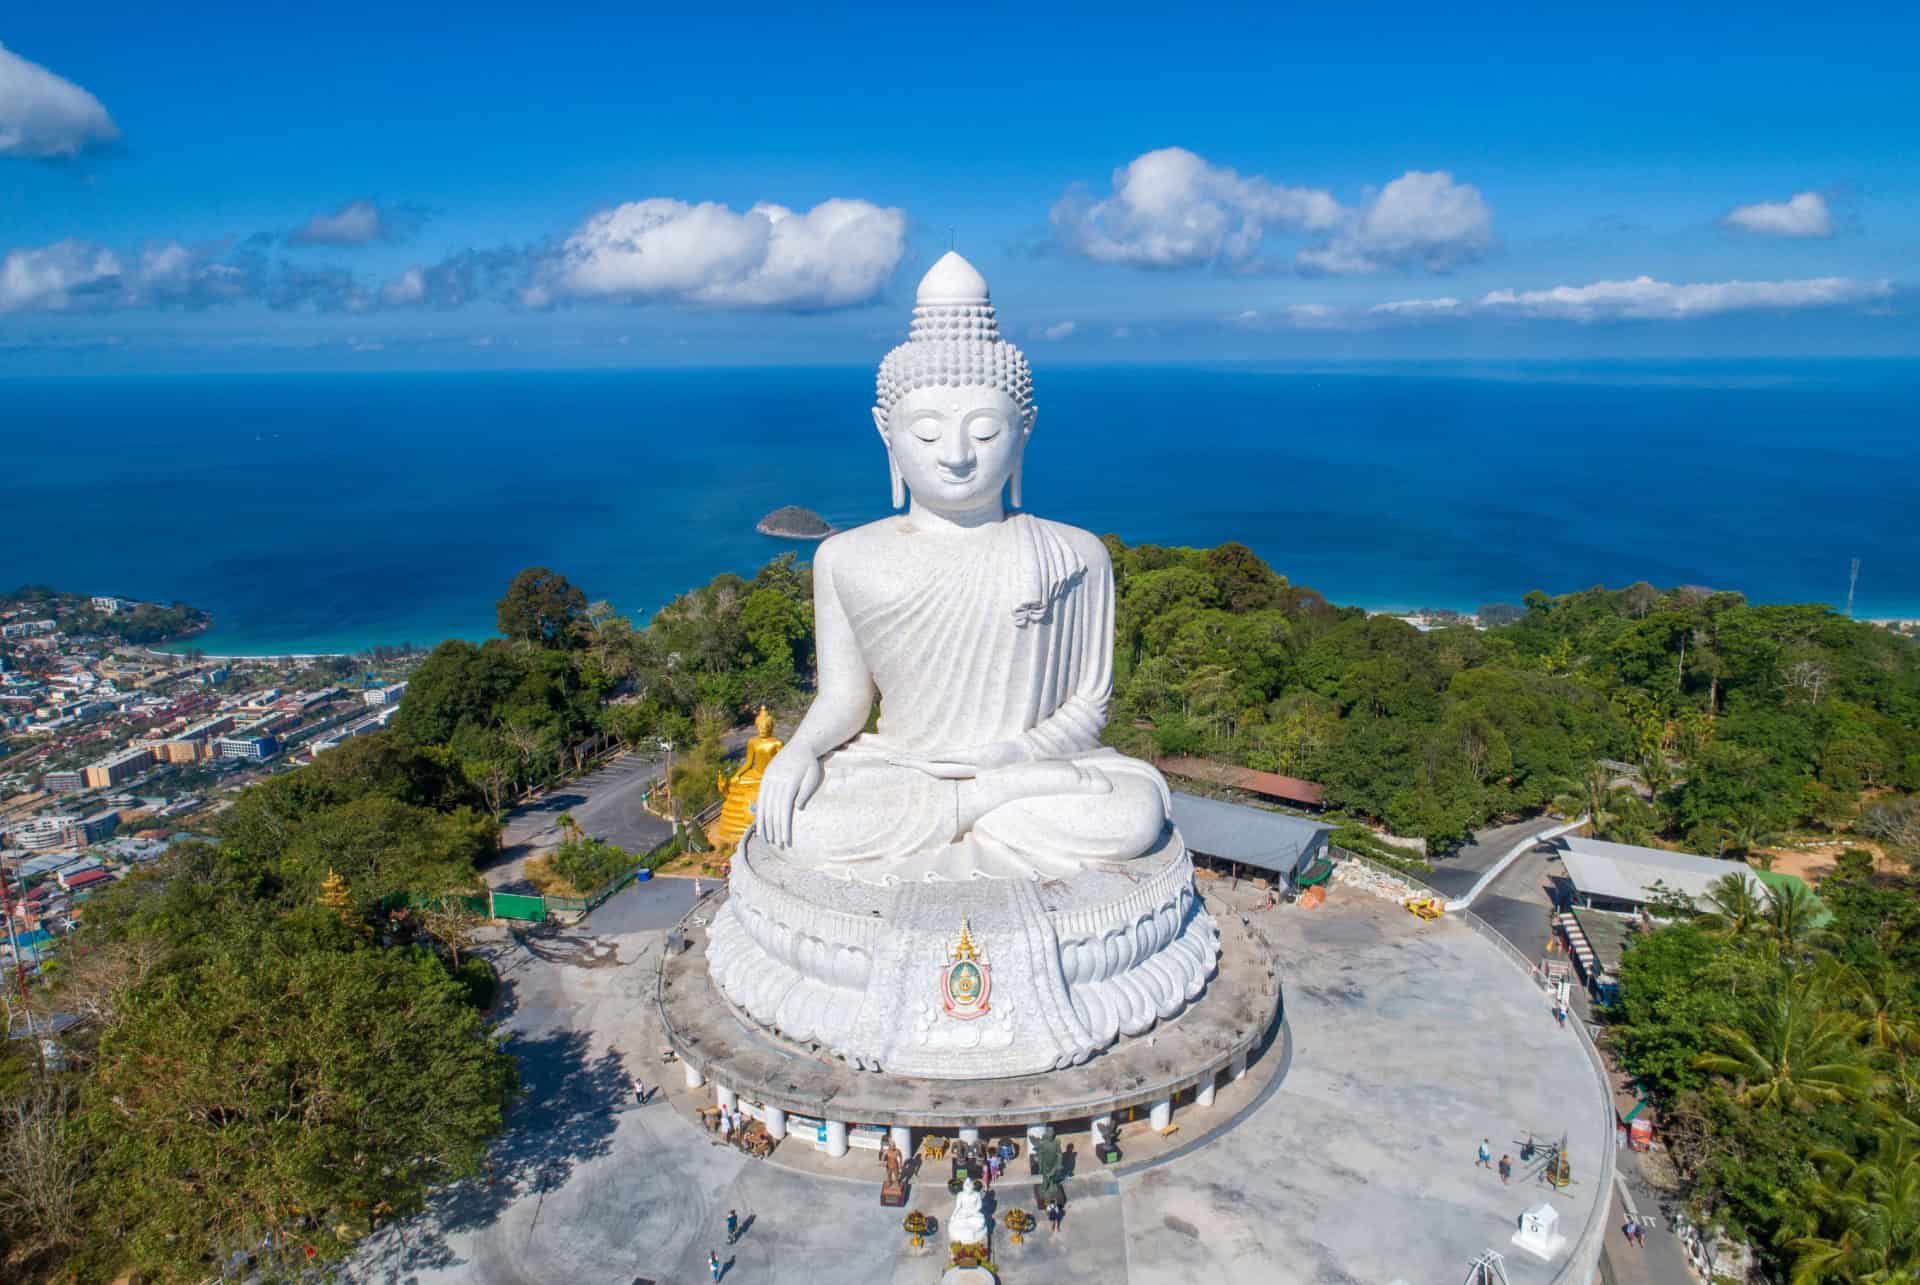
top-left (707, 828), bottom-right (1219, 1079)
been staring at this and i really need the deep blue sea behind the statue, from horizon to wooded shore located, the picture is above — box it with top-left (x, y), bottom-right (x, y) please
top-left (0, 361), bottom-right (1920, 653)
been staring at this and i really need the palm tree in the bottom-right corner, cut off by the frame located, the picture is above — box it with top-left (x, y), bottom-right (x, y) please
top-left (1780, 1124), bottom-right (1920, 1285)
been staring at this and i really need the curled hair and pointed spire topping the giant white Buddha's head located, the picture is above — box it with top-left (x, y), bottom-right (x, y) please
top-left (876, 250), bottom-right (1033, 411)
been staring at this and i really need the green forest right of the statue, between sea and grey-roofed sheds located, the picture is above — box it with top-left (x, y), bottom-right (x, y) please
top-left (1108, 538), bottom-right (1920, 855)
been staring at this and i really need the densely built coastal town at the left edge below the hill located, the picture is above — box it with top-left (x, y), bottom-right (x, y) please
top-left (0, 595), bottom-right (428, 972)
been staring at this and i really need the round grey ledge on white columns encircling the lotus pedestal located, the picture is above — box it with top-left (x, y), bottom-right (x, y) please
top-left (655, 883), bottom-right (1281, 1154)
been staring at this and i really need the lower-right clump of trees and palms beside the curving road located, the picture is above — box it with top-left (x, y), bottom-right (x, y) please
top-left (1605, 852), bottom-right (1920, 1285)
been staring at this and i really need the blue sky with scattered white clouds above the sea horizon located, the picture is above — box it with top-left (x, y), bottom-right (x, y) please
top-left (0, 2), bottom-right (1920, 375)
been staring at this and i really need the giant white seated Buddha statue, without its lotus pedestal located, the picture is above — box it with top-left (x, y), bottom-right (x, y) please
top-left (755, 254), bottom-right (1167, 882)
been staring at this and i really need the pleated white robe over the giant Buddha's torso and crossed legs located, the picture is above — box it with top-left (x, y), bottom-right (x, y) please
top-left (785, 515), bottom-right (1169, 880)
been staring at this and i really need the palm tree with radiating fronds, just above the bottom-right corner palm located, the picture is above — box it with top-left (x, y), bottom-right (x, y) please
top-left (1693, 976), bottom-right (1874, 1108)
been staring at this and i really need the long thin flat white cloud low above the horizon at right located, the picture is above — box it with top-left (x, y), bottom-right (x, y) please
top-left (1478, 277), bottom-right (1893, 321)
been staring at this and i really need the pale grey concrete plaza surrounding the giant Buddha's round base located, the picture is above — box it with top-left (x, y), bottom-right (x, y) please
top-left (353, 880), bottom-right (1613, 1285)
